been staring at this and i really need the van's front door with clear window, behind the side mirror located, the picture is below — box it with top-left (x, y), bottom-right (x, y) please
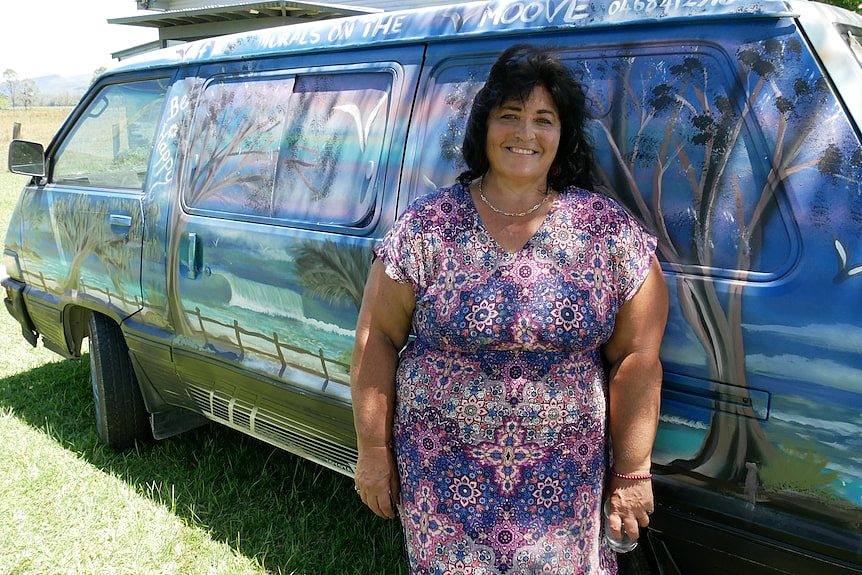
top-left (20, 78), bottom-right (168, 352)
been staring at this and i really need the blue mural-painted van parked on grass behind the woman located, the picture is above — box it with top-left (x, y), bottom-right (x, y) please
top-left (2, 0), bottom-right (862, 575)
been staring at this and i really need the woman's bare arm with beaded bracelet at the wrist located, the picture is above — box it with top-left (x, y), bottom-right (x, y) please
top-left (604, 258), bottom-right (668, 539)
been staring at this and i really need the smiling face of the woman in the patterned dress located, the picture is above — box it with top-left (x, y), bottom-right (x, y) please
top-left (485, 86), bottom-right (561, 185)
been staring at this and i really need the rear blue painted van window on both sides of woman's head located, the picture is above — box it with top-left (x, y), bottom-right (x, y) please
top-left (413, 46), bottom-right (797, 281)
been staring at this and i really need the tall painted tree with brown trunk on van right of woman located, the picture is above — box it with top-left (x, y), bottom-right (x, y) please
top-left (585, 38), bottom-right (852, 482)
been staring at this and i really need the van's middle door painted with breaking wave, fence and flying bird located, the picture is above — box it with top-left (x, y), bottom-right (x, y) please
top-left (168, 46), bottom-right (422, 472)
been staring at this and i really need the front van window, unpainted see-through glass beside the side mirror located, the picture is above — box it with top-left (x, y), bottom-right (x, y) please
top-left (52, 79), bottom-right (168, 190)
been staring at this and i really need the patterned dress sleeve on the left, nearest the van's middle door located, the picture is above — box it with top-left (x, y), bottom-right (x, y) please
top-left (374, 201), bottom-right (426, 294)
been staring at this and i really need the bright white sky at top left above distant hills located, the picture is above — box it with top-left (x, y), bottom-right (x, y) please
top-left (0, 0), bottom-right (158, 79)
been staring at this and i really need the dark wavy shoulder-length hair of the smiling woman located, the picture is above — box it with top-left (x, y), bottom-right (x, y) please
top-left (458, 44), bottom-right (595, 190)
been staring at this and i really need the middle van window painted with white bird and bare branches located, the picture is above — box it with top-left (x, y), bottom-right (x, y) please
top-left (189, 72), bottom-right (392, 226)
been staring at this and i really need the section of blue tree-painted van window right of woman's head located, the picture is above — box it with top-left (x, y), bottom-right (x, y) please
top-left (572, 50), bottom-right (801, 281)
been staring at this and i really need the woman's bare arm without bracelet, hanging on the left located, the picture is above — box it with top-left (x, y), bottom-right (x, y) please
top-left (350, 260), bottom-right (415, 518)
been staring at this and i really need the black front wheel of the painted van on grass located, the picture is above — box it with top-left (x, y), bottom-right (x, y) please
top-left (89, 313), bottom-right (152, 449)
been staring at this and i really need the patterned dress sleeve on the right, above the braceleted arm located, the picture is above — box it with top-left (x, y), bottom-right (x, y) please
top-left (608, 205), bottom-right (657, 305)
